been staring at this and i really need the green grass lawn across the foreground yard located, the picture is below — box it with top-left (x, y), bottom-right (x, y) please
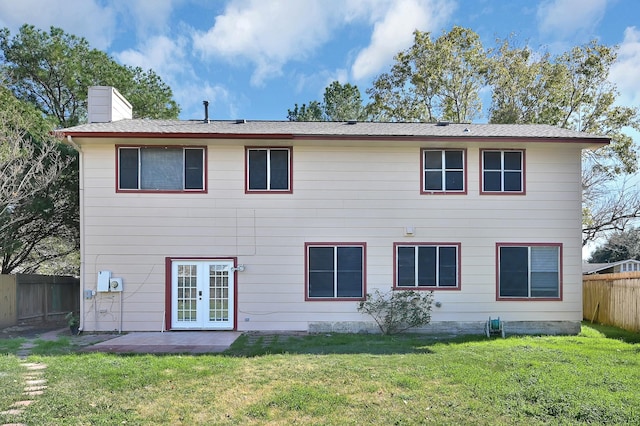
top-left (0, 323), bottom-right (640, 425)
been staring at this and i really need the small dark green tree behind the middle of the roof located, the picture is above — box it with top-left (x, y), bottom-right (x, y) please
top-left (287, 81), bottom-right (367, 121)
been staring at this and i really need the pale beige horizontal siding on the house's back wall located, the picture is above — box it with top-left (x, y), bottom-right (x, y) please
top-left (83, 140), bottom-right (582, 330)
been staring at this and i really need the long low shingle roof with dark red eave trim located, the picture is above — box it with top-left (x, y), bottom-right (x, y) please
top-left (60, 119), bottom-right (609, 144)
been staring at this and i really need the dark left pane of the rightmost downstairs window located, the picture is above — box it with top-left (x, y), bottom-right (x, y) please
top-left (499, 247), bottom-right (529, 297)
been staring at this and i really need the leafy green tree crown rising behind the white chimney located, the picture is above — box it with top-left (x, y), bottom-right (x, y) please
top-left (0, 25), bottom-right (180, 127)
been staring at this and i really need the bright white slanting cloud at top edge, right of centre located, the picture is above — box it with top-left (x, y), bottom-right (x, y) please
top-left (351, 0), bottom-right (455, 80)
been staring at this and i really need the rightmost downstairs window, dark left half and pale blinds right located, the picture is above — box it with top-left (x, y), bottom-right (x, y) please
top-left (498, 244), bottom-right (561, 299)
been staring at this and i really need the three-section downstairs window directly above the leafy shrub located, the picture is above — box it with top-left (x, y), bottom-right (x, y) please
top-left (394, 243), bottom-right (460, 289)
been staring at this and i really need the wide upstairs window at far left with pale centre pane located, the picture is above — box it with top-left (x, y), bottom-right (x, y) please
top-left (118, 147), bottom-right (205, 192)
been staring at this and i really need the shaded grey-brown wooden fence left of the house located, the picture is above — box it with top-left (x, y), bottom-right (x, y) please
top-left (0, 274), bottom-right (80, 327)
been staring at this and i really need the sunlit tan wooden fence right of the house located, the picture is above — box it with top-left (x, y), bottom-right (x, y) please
top-left (582, 272), bottom-right (640, 331)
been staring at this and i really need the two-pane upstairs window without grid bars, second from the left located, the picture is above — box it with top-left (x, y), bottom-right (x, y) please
top-left (246, 148), bottom-right (291, 193)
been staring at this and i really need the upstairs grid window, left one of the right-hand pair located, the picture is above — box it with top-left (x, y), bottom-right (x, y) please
top-left (422, 149), bottom-right (466, 193)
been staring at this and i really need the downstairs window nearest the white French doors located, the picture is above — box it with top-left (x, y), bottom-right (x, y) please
top-left (306, 244), bottom-right (365, 300)
